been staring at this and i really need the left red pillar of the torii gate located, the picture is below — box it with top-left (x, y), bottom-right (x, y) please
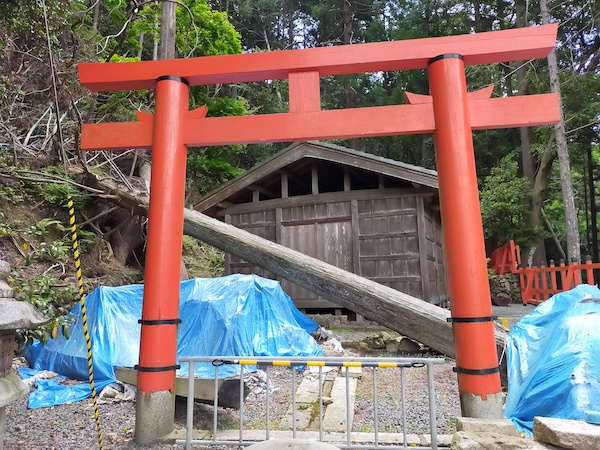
top-left (137, 80), bottom-right (189, 393)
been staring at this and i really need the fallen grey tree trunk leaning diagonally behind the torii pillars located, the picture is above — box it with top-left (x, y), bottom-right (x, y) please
top-left (77, 174), bottom-right (507, 358)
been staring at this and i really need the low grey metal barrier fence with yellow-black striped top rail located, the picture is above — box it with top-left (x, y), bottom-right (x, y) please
top-left (176, 356), bottom-right (445, 450)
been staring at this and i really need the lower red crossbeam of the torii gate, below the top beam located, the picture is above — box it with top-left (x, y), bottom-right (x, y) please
top-left (81, 94), bottom-right (560, 150)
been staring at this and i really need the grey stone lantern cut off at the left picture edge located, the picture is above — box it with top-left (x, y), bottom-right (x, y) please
top-left (0, 260), bottom-right (48, 450)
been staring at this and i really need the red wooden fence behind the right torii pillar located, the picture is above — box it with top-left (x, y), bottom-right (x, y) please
top-left (489, 241), bottom-right (600, 305)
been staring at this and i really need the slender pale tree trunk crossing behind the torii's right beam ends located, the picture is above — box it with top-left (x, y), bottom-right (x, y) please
top-left (540, 0), bottom-right (581, 261)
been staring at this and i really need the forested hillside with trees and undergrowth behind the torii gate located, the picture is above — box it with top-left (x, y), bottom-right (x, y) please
top-left (0, 0), bottom-right (600, 344)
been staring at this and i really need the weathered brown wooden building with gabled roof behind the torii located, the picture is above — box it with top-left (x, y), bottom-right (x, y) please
top-left (195, 141), bottom-right (447, 310)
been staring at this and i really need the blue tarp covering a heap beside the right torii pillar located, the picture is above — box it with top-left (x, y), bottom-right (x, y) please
top-left (504, 284), bottom-right (600, 435)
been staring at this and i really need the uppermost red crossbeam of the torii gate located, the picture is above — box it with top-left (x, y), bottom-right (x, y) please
top-left (78, 24), bottom-right (558, 91)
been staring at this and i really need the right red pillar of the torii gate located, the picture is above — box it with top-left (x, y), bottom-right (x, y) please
top-left (428, 57), bottom-right (502, 401)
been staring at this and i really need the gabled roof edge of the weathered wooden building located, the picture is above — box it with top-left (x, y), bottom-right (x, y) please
top-left (194, 141), bottom-right (438, 212)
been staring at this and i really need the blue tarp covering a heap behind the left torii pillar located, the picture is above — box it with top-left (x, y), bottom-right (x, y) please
top-left (28, 275), bottom-right (323, 408)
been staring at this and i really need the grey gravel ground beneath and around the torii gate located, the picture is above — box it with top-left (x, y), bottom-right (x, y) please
top-left (4, 330), bottom-right (460, 450)
